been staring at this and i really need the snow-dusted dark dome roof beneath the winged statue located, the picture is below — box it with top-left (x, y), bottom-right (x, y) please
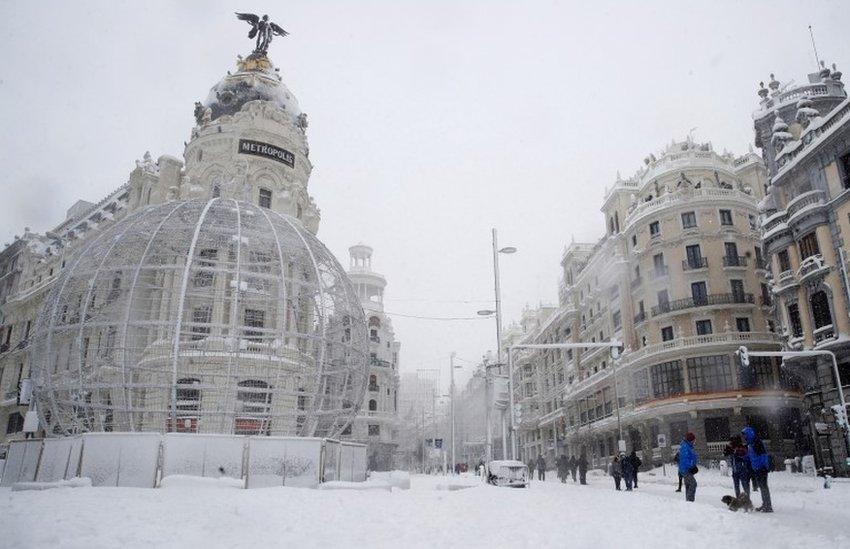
top-left (204, 57), bottom-right (301, 122)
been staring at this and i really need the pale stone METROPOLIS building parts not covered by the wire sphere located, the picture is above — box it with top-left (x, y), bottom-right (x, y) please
top-left (0, 52), bottom-right (328, 453)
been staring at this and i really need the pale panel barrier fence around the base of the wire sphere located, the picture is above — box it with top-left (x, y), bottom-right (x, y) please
top-left (0, 433), bottom-right (366, 488)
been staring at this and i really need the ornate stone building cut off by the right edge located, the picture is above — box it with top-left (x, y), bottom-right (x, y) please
top-left (754, 60), bottom-right (850, 474)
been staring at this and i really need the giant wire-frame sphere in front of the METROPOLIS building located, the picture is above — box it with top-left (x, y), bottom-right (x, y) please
top-left (31, 198), bottom-right (368, 436)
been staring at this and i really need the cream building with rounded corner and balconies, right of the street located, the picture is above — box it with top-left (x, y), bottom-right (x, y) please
top-left (514, 139), bottom-right (803, 466)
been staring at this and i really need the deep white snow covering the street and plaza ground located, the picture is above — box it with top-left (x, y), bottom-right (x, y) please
top-left (0, 468), bottom-right (850, 549)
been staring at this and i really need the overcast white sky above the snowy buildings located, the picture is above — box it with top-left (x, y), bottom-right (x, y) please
top-left (0, 0), bottom-right (850, 392)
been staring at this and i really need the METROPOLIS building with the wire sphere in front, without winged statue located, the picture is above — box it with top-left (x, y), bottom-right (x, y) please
top-left (0, 34), bottom-right (369, 448)
